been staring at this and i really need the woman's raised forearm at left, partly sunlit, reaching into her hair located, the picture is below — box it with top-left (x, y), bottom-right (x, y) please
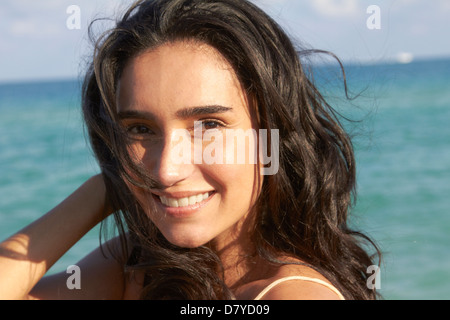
top-left (0, 176), bottom-right (111, 299)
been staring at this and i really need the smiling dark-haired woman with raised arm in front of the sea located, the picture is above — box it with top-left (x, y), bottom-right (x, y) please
top-left (0, 0), bottom-right (378, 299)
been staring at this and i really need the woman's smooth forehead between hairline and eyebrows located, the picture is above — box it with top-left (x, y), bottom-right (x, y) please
top-left (117, 42), bottom-right (246, 111)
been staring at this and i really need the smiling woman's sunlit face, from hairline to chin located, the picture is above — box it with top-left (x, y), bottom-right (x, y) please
top-left (117, 42), bottom-right (262, 247)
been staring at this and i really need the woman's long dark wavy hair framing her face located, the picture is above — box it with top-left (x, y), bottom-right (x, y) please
top-left (82, 0), bottom-right (381, 299)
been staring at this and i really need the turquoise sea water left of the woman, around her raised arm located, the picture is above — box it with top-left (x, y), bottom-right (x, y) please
top-left (0, 80), bottom-right (99, 272)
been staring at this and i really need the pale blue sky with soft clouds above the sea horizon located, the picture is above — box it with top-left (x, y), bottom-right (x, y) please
top-left (0, 0), bottom-right (450, 82)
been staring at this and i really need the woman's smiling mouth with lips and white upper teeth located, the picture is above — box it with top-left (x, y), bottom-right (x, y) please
top-left (153, 191), bottom-right (215, 218)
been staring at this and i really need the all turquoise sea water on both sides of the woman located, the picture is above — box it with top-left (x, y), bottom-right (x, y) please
top-left (0, 59), bottom-right (450, 300)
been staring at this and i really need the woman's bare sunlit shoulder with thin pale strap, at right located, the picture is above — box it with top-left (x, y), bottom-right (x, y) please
top-left (253, 265), bottom-right (342, 300)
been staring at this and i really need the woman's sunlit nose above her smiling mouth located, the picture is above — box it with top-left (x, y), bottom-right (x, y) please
top-left (146, 130), bottom-right (195, 187)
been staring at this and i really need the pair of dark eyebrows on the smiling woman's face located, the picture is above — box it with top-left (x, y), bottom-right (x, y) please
top-left (118, 105), bottom-right (233, 120)
